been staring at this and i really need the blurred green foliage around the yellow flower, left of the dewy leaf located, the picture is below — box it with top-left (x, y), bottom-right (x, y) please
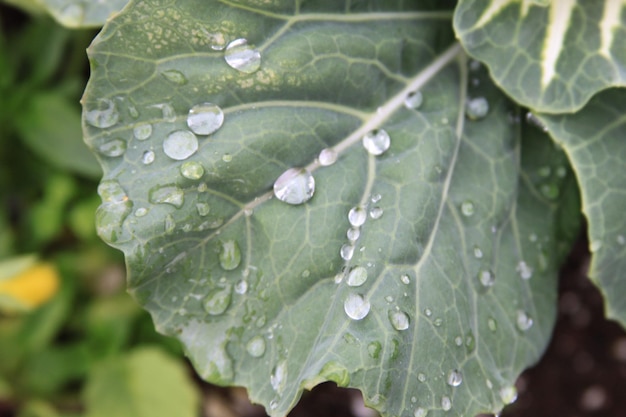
top-left (0, 4), bottom-right (198, 417)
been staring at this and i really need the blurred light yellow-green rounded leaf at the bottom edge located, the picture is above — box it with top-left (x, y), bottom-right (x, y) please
top-left (84, 348), bottom-right (199, 417)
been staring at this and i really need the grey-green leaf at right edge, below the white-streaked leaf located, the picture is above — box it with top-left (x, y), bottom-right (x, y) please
top-left (537, 89), bottom-right (626, 326)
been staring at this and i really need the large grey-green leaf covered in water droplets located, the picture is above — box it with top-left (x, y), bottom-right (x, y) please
top-left (83, 0), bottom-right (579, 416)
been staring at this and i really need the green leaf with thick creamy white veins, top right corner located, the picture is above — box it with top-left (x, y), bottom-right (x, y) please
top-left (454, 0), bottom-right (626, 113)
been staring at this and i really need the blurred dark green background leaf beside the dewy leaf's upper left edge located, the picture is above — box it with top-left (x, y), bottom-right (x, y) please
top-left (15, 92), bottom-right (102, 179)
